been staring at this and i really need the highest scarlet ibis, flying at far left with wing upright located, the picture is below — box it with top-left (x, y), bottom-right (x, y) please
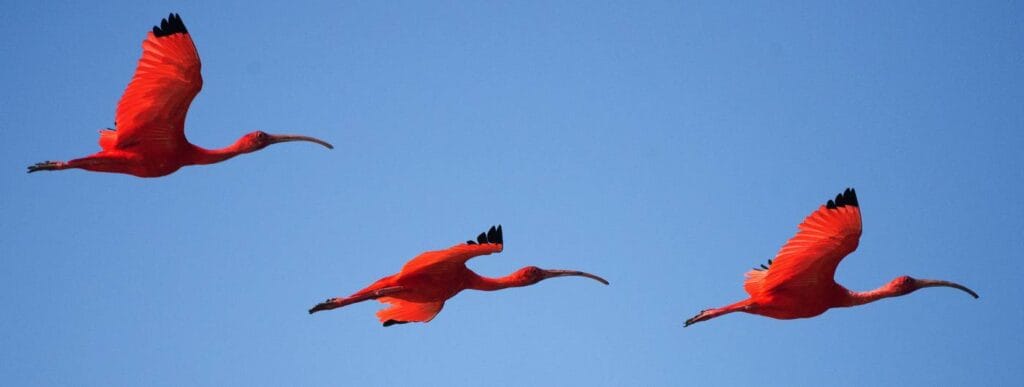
top-left (29, 13), bottom-right (334, 177)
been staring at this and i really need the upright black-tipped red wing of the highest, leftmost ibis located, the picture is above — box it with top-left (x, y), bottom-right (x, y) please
top-left (110, 13), bottom-right (203, 149)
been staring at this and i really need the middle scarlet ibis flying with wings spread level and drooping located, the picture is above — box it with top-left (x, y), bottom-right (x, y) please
top-left (309, 225), bottom-right (608, 327)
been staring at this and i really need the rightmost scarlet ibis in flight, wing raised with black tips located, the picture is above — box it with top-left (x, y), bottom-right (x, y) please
top-left (686, 188), bottom-right (978, 327)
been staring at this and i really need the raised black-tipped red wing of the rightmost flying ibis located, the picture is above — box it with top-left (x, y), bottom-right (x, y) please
top-left (743, 188), bottom-right (861, 296)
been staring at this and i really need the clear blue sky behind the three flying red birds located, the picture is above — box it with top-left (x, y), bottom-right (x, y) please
top-left (0, 1), bottom-right (1024, 386)
